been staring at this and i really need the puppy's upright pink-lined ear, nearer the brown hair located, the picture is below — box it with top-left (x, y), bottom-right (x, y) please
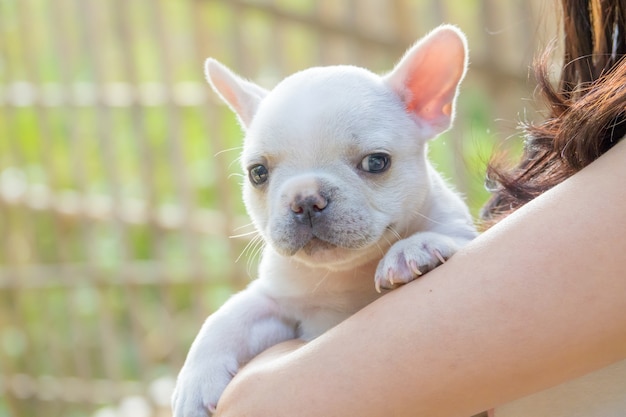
top-left (383, 25), bottom-right (467, 136)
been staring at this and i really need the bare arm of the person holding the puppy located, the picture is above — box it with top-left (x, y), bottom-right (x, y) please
top-left (213, 141), bottom-right (626, 417)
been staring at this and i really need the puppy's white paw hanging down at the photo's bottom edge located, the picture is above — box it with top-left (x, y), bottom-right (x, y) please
top-left (172, 357), bottom-right (238, 417)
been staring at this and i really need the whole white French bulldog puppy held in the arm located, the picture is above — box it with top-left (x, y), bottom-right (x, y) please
top-left (173, 26), bottom-right (476, 417)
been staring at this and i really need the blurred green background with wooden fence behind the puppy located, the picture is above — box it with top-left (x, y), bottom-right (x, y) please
top-left (0, 0), bottom-right (557, 417)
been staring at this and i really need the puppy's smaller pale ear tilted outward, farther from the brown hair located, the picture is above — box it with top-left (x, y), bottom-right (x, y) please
top-left (204, 58), bottom-right (267, 129)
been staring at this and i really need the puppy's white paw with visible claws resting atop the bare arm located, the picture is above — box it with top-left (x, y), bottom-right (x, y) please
top-left (374, 232), bottom-right (458, 292)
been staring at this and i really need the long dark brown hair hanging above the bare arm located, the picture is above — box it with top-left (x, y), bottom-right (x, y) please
top-left (481, 0), bottom-right (626, 226)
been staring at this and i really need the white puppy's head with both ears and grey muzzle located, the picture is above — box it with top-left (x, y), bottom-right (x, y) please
top-left (206, 26), bottom-right (467, 269)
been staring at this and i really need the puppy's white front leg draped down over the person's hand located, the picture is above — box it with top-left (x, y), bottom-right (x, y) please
top-left (172, 287), bottom-right (296, 417)
